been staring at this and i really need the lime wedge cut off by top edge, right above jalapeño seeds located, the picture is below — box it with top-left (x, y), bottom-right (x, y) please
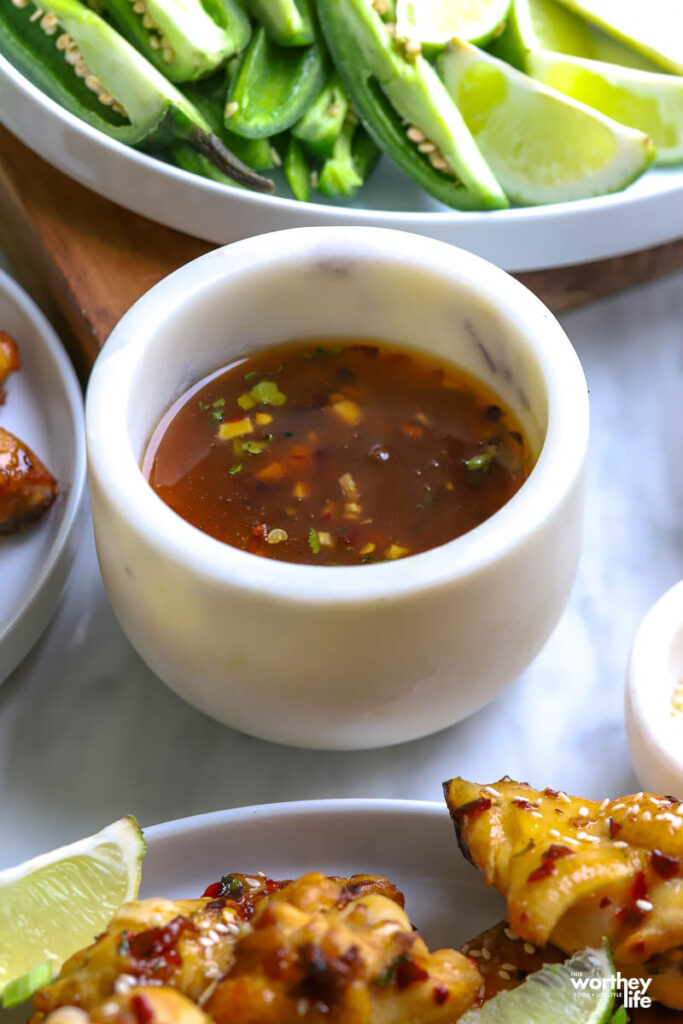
top-left (396, 0), bottom-right (510, 47)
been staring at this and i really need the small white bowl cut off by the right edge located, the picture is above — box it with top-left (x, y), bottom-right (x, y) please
top-left (626, 581), bottom-right (683, 801)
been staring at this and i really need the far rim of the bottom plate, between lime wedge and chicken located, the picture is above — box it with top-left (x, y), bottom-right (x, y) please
top-left (142, 797), bottom-right (449, 850)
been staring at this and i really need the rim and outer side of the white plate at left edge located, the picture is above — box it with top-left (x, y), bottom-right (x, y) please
top-left (0, 270), bottom-right (86, 683)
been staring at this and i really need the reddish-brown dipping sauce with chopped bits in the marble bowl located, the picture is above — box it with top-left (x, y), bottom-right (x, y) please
top-left (142, 340), bottom-right (533, 565)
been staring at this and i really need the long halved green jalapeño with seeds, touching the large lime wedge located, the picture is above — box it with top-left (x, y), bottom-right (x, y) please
top-left (317, 0), bottom-right (508, 210)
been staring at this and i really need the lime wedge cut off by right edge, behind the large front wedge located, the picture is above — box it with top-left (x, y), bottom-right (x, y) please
top-left (526, 51), bottom-right (683, 164)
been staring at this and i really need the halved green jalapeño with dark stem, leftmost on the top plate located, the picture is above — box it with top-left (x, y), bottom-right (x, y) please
top-left (0, 0), bottom-right (273, 191)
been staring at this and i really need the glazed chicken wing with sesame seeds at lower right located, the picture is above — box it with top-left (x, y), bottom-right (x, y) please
top-left (444, 778), bottom-right (683, 1009)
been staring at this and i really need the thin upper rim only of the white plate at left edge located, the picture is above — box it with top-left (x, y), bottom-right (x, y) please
top-left (0, 269), bottom-right (87, 644)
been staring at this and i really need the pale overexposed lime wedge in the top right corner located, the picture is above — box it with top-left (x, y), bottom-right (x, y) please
top-left (561, 0), bottom-right (683, 75)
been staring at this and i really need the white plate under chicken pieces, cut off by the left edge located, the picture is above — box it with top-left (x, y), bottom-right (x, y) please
top-left (0, 271), bottom-right (86, 683)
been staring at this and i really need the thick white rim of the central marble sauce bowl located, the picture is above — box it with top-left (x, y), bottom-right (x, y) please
top-left (86, 227), bottom-right (589, 605)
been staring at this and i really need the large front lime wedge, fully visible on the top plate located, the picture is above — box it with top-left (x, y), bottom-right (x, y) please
top-left (439, 41), bottom-right (654, 206)
